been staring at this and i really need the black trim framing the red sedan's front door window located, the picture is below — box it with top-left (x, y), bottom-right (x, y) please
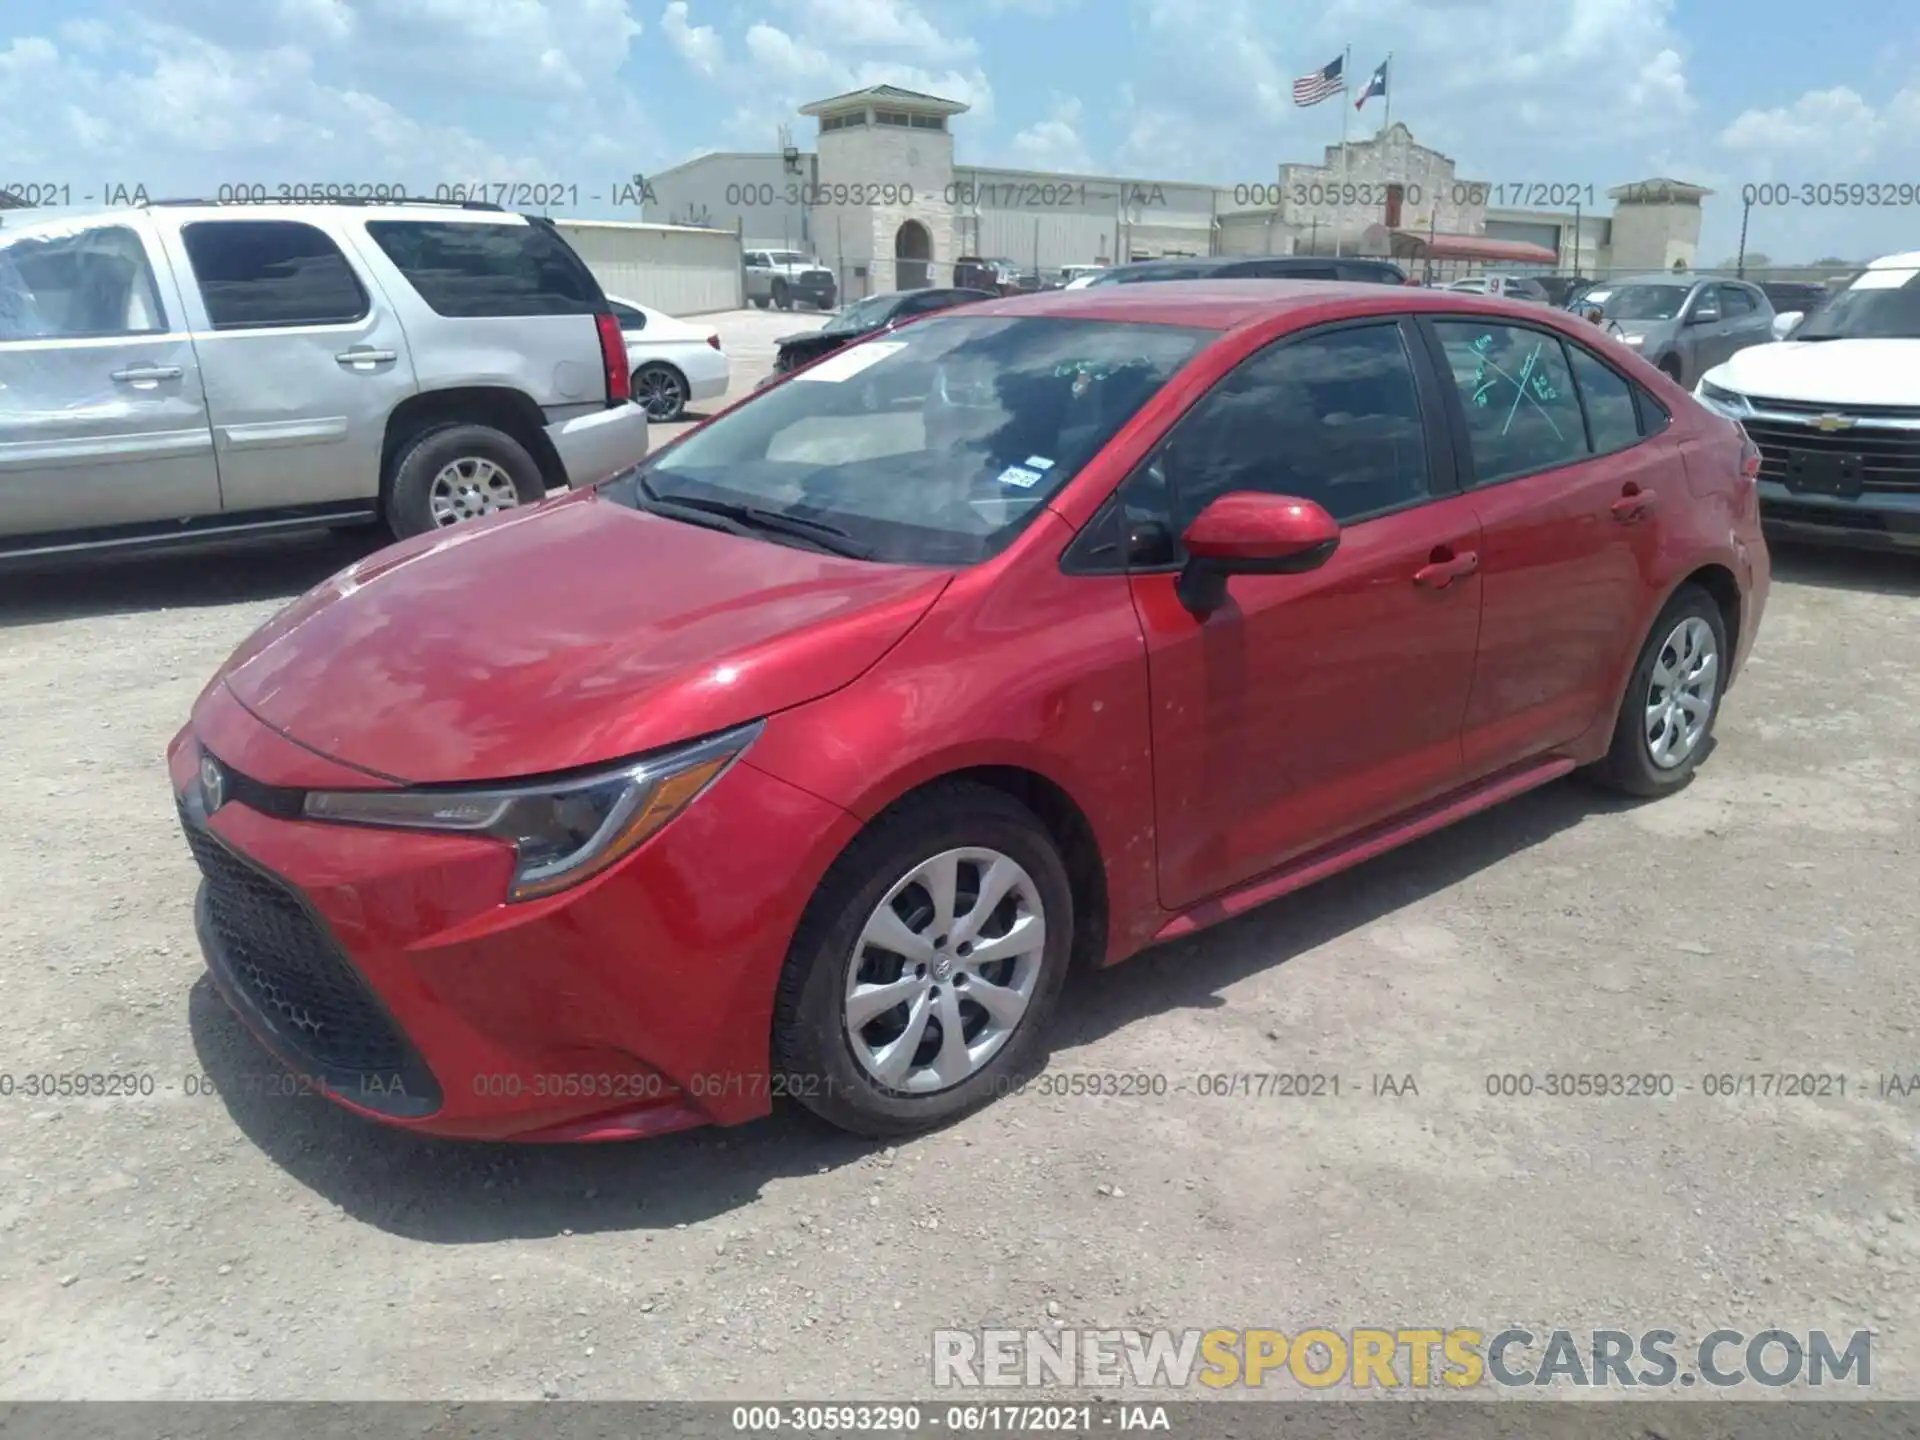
top-left (1060, 311), bottom-right (1465, 576)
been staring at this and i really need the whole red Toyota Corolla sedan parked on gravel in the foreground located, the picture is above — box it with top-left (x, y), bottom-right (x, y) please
top-left (169, 280), bottom-right (1768, 1140)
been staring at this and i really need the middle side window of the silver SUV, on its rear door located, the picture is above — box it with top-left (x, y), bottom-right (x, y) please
top-left (180, 221), bottom-right (367, 330)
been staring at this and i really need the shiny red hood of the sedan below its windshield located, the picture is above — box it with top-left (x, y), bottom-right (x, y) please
top-left (221, 492), bottom-right (950, 783)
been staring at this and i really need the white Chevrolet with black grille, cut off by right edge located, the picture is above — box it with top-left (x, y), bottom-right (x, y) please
top-left (1695, 250), bottom-right (1920, 551)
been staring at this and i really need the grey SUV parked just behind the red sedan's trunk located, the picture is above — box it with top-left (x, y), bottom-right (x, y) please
top-left (1580, 275), bottom-right (1774, 386)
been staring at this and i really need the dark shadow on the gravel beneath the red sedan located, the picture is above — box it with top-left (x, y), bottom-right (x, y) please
top-left (188, 783), bottom-right (1620, 1244)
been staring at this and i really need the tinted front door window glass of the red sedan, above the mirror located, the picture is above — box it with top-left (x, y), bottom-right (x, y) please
top-left (1164, 321), bottom-right (1428, 534)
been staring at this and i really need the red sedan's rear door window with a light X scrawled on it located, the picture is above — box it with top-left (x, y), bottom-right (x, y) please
top-left (1434, 321), bottom-right (1588, 486)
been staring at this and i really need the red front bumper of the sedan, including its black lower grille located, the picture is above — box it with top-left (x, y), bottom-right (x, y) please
top-left (167, 687), bottom-right (856, 1140)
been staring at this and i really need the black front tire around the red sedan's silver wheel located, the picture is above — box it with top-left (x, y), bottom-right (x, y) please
top-left (774, 781), bottom-right (1073, 1139)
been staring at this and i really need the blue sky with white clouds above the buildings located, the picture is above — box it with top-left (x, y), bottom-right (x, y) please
top-left (0, 0), bottom-right (1920, 263)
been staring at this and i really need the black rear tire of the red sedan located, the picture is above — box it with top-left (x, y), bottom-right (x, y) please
top-left (1590, 586), bottom-right (1728, 797)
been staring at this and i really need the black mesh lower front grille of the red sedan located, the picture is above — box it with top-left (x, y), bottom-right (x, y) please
top-left (180, 816), bottom-right (413, 1077)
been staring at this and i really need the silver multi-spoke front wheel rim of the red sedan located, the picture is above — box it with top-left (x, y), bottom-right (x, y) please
top-left (843, 847), bottom-right (1046, 1094)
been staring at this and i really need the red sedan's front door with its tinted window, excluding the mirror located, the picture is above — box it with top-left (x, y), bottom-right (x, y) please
top-left (1127, 319), bottom-right (1480, 910)
